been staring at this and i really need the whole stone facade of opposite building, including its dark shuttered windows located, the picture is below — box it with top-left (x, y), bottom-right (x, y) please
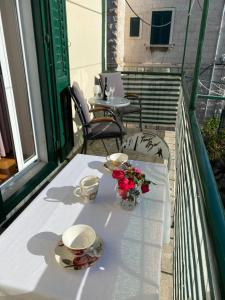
top-left (114, 0), bottom-right (225, 119)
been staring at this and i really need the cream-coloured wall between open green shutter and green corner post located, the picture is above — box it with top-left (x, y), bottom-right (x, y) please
top-left (66, 0), bottom-right (102, 147)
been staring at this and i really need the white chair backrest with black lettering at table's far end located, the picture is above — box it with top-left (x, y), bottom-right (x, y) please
top-left (121, 132), bottom-right (170, 169)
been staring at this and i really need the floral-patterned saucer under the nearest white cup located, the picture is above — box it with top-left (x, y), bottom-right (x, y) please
top-left (55, 236), bottom-right (103, 270)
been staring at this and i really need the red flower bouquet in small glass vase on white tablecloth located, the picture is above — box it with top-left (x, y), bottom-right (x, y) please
top-left (112, 162), bottom-right (151, 209)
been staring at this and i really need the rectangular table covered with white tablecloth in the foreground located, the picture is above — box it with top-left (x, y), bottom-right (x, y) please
top-left (0, 154), bottom-right (169, 300)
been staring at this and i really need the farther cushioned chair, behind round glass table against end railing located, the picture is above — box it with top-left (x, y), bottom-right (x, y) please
top-left (99, 72), bottom-right (142, 131)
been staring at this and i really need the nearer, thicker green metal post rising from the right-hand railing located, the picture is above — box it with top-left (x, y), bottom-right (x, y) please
top-left (189, 0), bottom-right (209, 110)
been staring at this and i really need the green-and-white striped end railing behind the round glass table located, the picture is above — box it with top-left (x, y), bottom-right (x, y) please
top-left (122, 71), bottom-right (181, 127)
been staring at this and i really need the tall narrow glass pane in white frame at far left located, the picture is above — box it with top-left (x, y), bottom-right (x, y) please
top-left (1, 1), bottom-right (36, 161)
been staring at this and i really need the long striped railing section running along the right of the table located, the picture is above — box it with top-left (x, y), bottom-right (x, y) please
top-left (174, 81), bottom-right (225, 300)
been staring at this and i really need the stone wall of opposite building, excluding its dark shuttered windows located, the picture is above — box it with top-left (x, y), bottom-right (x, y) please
top-left (118, 0), bottom-right (225, 121)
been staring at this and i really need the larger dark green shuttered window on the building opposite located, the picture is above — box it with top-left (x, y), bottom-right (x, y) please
top-left (150, 11), bottom-right (172, 45)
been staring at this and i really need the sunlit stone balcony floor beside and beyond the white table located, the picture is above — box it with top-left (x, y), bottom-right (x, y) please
top-left (87, 124), bottom-right (176, 300)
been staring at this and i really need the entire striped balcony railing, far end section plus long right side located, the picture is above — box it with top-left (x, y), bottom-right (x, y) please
top-left (119, 72), bottom-right (225, 300)
